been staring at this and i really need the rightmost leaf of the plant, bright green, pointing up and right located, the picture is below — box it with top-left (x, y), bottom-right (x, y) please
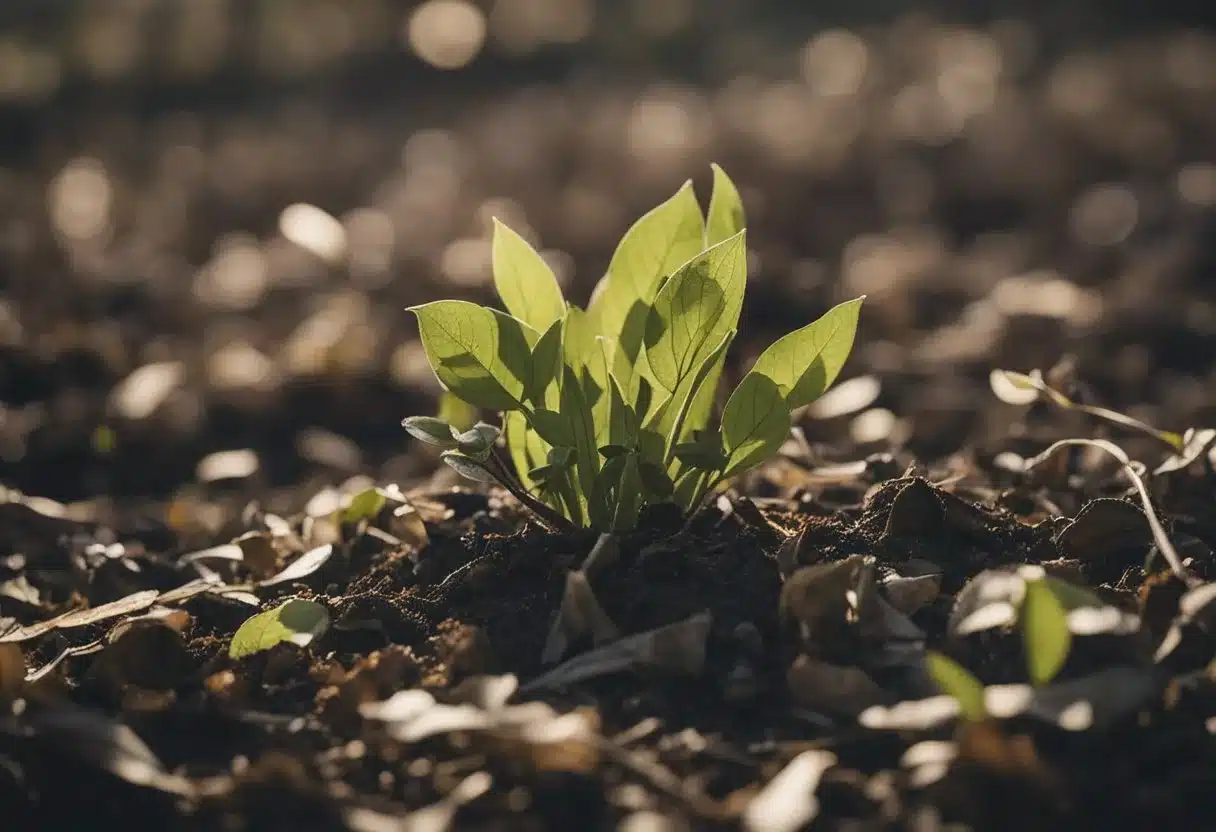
top-left (751, 296), bottom-right (866, 410)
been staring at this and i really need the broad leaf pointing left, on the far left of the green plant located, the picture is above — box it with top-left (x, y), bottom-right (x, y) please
top-left (409, 300), bottom-right (539, 410)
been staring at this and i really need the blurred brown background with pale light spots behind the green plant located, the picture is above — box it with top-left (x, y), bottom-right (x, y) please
top-left (0, 0), bottom-right (1216, 515)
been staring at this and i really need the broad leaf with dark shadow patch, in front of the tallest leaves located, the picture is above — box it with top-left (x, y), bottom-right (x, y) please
top-left (646, 231), bottom-right (747, 393)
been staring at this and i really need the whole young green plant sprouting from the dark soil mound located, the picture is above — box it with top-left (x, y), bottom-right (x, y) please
top-left (404, 165), bottom-right (863, 532)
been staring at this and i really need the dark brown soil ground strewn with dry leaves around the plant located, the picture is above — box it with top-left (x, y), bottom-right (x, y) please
top-left (0, 4), bottom-right (1216, 832)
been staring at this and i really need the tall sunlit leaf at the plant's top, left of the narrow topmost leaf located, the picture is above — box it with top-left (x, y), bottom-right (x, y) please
top-left (587, 181), bottom-right (705, 350)
